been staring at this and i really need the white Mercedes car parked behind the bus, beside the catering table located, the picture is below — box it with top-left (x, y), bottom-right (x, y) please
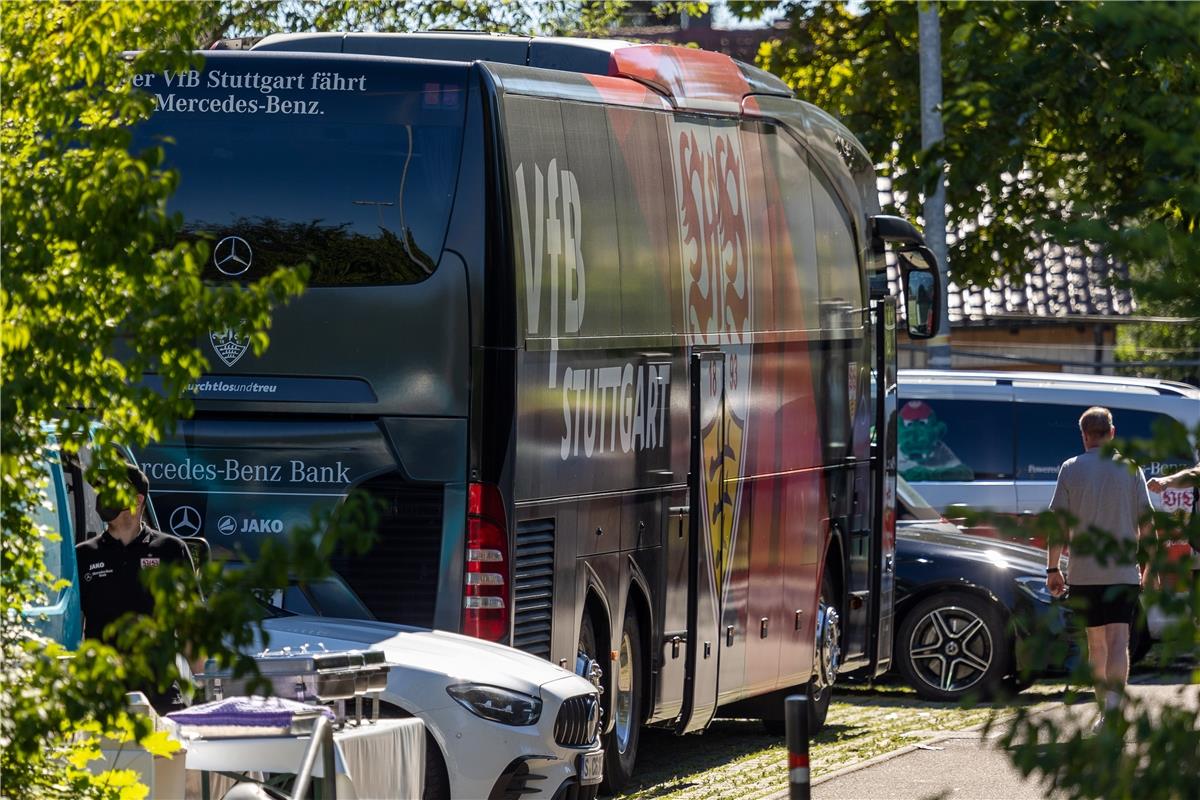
top-left (264, 614), bottom-right (604, 800)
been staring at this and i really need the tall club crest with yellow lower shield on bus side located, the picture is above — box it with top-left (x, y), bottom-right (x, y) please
top-left (670, 120), bottom-right (752, 604)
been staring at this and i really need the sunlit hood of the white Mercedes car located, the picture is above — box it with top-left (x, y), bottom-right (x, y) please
top-left (263, 614), bottom-right (574, 694)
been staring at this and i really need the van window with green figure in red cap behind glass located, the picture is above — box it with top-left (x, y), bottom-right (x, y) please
top-left (896, 399), bottom-right (1013, 481)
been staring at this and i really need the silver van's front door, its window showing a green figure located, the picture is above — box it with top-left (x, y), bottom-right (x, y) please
top-left (896, 379), bottom-right (1016, 513)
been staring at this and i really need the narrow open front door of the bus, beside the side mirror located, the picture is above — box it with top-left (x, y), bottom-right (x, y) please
top-left (869, 297), bottom-right (896, 675)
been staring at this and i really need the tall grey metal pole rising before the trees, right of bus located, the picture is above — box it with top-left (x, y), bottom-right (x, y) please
top-left (917, 0), bottom-right (950, 369)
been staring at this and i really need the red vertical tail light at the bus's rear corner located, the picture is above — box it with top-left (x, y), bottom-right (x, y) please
top-left (462, 483), bottom-right (509, 642)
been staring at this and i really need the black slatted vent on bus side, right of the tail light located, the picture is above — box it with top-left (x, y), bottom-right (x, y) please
top-left (512, 519), bottom-right (554, 658)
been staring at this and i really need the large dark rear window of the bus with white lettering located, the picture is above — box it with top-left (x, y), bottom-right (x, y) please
top-left (134, 54), bottom-right (466, 285)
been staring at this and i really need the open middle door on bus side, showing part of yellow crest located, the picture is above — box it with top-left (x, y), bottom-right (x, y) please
top-left (676, 353), bottom-right (731, 733)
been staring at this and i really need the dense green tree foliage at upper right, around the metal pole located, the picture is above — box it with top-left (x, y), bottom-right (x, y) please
top-left (748, 0), bottom-right (1200, 317)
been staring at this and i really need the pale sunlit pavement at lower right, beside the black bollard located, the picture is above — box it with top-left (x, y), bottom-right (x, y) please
top-left (792, 675), bottom-right (1200, 800)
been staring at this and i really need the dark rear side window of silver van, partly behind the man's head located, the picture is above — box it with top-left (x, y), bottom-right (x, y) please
top-left (1016, 403), bottom-right (1190, 481)
